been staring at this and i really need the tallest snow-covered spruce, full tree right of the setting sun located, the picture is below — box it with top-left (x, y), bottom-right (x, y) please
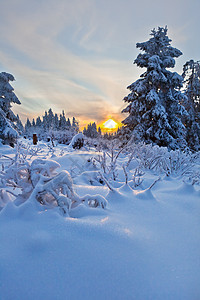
top-left (122, 27), bottom-right (187, 149)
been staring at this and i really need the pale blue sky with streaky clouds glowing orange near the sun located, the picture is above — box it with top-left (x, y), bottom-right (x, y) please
top-left (0, 0), bottom-right (200, 126)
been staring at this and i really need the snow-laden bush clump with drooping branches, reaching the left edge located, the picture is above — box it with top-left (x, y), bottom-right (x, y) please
top-left (0, 144), bottom-right (107, 214)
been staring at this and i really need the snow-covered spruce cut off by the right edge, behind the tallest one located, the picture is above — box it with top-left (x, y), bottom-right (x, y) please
top-left (182, 59), bottom-right (200, 151)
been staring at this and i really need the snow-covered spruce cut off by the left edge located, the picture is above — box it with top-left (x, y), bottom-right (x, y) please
top-left (0, 72), bottom-right (21, 146)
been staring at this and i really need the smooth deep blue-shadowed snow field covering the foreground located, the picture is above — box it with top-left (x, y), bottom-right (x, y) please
top-left (0, 142), bottom-right (200, 300)
